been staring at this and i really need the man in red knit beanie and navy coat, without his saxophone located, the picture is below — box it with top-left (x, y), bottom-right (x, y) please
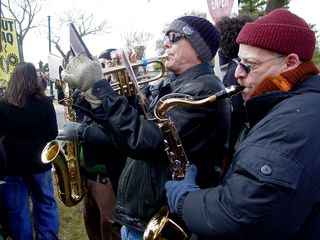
top-left (165, 9), bottom-right (320, 240)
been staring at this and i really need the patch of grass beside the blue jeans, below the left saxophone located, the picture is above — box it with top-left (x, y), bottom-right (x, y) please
top-left (56, 188), bottom-right (88, 240)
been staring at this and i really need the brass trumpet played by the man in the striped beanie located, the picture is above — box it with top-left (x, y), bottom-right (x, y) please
top-left (102, 58), bottom-right (165, 96)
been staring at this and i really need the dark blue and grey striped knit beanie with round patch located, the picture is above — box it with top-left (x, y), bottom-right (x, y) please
top-left (166, 16), bottom-right (221, 62)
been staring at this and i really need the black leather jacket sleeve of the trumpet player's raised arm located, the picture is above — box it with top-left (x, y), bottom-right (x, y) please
top-left (92, 80), bottom-right (165, 160)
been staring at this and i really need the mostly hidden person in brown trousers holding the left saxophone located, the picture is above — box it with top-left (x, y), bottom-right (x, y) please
top-left (72, 93), bottom-right (126, 240)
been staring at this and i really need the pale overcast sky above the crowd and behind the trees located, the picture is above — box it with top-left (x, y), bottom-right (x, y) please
top-left (18, 0), bottom-right (320, 64)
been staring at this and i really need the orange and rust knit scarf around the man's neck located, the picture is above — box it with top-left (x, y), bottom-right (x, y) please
top-left (253, 61), bottom-right (319, 97)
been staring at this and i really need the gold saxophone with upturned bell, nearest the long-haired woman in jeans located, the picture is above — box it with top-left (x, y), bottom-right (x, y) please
top-left (41, 86), bottom-right (85, 207)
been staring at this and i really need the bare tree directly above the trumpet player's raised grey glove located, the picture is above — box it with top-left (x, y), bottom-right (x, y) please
top-left (51, 9), bottom-right (108, 65)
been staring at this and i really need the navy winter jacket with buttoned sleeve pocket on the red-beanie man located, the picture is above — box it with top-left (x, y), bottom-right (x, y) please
top-left (182, 76), bottom-right (320, 240)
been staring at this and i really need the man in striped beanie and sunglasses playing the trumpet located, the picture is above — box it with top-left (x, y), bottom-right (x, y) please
top-left (63, 16), bottom-right (229, 239)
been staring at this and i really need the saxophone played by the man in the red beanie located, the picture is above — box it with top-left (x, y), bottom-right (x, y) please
top-left (143, 85), bottom-right (243, 240)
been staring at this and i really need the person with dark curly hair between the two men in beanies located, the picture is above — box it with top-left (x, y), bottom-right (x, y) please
top-left (216, 15), bottom-right (255, 163)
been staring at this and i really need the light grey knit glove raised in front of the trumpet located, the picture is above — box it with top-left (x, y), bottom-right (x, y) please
top-left (61, 53), bottom-right (103, 92)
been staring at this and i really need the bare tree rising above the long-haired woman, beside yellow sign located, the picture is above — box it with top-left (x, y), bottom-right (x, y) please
top-left (1, 0), bottom-right (44, 61)
